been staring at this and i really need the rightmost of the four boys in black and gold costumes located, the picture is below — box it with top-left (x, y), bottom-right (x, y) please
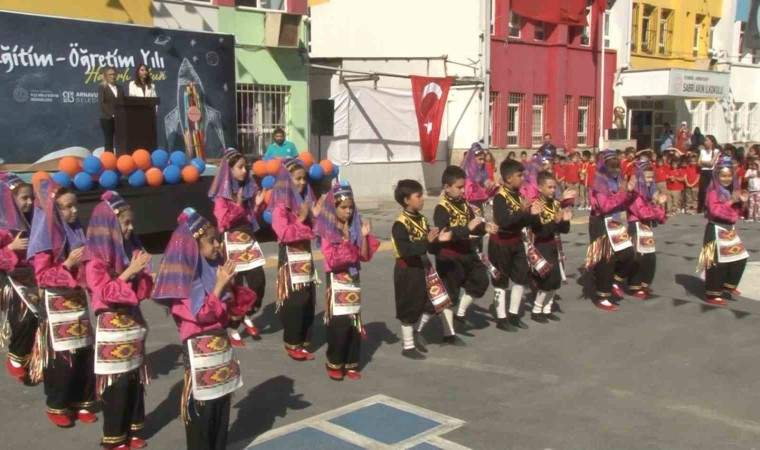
top-left (530, 171), bottom-right (573, 323)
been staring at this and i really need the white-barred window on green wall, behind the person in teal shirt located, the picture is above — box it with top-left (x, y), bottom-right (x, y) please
top-left (237, 83), bottom-right (290, 156)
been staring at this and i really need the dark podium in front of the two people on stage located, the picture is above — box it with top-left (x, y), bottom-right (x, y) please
top-left (114, 97), bottom-right (161, 155)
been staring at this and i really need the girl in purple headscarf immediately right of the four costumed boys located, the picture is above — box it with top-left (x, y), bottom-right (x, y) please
top-left (584, 150), bottom-right (636, 311)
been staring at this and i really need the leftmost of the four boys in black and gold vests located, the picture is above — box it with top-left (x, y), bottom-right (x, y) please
top-left (391, 180), bottom-right (455, 360)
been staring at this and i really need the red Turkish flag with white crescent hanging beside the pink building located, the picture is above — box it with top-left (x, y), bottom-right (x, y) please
top-left (411, 75), bottom-right (454, 164)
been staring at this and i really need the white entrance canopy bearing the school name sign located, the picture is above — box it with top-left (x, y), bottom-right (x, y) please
top-left (620, 69), bottom-right (731, 98)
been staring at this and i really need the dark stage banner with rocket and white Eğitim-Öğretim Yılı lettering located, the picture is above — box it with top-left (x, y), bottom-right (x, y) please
top-left (0, 11), bottom-right (236, 163)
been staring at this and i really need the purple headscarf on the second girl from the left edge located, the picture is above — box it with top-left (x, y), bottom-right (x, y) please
top-left (26, 180), bottom-right (85, 262)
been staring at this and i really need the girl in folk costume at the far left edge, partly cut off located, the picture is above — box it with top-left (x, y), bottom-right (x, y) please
top-left (0, 173), bottom-right (39, 382)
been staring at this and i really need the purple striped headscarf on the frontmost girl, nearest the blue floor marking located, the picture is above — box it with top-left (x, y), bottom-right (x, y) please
top-left (152, 208), bottom-right (229, 315)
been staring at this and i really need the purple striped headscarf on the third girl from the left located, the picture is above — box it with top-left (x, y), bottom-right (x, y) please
top-left (82, 191), bottom-right (143, 273)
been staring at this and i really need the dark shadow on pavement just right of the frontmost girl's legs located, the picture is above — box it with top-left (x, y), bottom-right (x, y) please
top-left (228, 375), bottom-right (311, 449)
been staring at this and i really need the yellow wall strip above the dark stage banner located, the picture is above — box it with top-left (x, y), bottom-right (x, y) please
top-left (0, 0), bottom-right (153, 25)
